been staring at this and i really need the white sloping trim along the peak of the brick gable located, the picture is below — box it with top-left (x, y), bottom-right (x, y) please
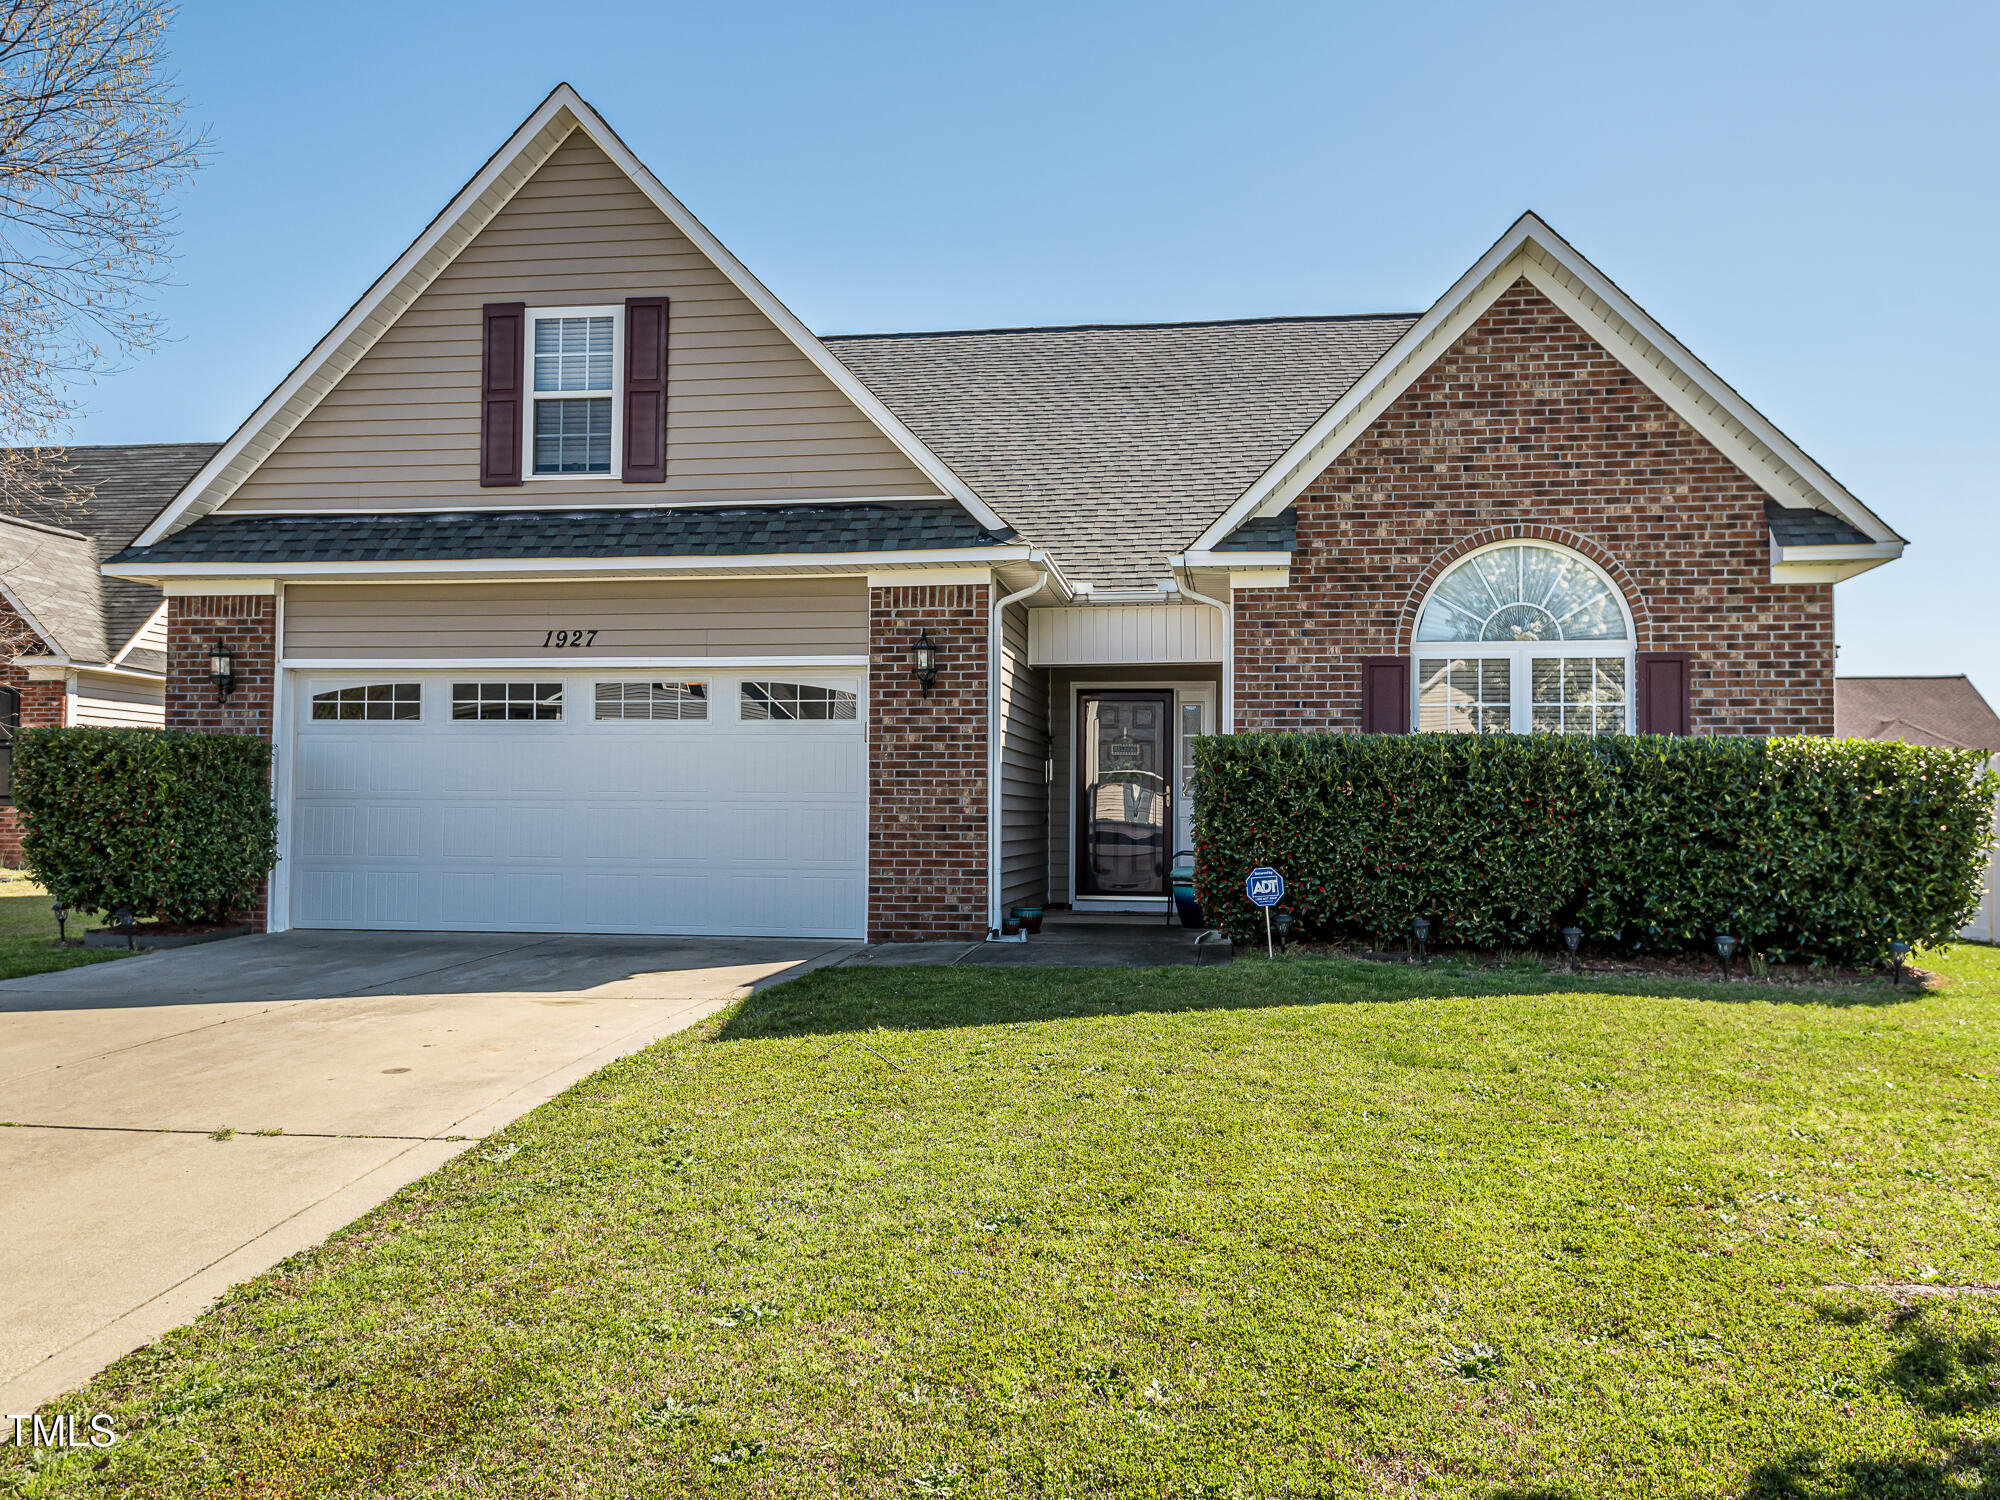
top-left (1188, 214), bottom-right (1902, 552)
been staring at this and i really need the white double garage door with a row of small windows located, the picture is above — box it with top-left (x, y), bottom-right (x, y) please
top-left (286, 668), bottom-right (868, 938)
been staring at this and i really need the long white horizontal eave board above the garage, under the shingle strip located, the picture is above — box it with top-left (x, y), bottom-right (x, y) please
top-left (104, 546), bottom-right (1042, 594)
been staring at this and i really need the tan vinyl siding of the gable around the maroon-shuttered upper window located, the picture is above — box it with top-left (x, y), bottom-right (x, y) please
top-left (222, 132), bottom-right (938, 510)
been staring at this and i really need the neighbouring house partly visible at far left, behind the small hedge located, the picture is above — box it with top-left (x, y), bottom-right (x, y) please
top-left (0, 442), bottom-right (216, 866)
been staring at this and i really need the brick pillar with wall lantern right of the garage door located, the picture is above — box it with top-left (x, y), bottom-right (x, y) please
top-left (868, 584), bottom-right (990, 942)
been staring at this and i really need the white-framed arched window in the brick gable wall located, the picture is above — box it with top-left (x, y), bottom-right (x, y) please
top-left (1414, 542), bottom-right (1632, 734)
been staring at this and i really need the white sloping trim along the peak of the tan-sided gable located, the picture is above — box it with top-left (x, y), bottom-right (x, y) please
top-left (138, 84), bottom-right (1002, 546)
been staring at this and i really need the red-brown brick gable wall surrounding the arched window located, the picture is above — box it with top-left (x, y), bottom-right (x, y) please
top-left (1234, 280), bottom-right (1834, 734)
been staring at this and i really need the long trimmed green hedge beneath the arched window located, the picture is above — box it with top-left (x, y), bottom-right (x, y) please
top-left (1194, 734), bottom-right (1996, 964)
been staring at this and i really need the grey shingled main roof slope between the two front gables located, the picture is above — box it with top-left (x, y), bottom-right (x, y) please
top-left (826, 314), bottom-right (1416, 588)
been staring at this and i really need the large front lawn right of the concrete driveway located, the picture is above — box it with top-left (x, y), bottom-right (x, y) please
top-left (0, 946), bottom-right (2000, 1500)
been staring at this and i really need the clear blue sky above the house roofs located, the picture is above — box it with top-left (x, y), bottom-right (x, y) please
top-left (66, 0), bottom-right (2000, 704)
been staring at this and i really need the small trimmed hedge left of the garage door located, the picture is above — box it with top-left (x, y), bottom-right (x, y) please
top-left (14, 730), bottom-right (278, 922)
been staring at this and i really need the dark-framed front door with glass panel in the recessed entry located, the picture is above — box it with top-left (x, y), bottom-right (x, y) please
top-left (1076, 692), bottom-right (1174, 896)
